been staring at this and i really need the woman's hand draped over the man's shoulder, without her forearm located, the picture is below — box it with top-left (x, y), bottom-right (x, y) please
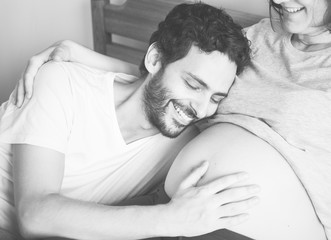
top-left (13, 40), bottom-right (70, 107)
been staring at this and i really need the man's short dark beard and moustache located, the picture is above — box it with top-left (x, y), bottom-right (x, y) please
top-left (143, 69), bottom-right (196, 138)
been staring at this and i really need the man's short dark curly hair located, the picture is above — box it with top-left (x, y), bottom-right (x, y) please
top-left (140, 2), bottom-right (250, 76)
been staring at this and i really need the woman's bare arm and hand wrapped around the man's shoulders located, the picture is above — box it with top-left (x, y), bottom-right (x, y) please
top-left (13, 40), bottom-right (139, 107)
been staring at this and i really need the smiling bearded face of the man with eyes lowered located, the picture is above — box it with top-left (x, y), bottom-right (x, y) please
top-left (144, 46), bottom-right (237, 138)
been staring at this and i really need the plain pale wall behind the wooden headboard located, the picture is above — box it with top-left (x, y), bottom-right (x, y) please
top-left (0, 0), bottom-right (268, 103)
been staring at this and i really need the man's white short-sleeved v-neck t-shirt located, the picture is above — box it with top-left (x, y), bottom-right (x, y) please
top-left (0, 63), bottom-right (197, 236)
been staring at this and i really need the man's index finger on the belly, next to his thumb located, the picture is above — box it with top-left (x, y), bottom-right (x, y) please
top-left (202, 172), bottom-right (248, 194)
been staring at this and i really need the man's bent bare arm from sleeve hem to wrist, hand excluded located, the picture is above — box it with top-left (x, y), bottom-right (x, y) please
top-left (13, 145), bottom-right (170, 239)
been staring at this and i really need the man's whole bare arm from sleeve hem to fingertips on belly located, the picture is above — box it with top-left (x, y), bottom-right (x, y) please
top-left (13, 144), bottom-right (256, 239)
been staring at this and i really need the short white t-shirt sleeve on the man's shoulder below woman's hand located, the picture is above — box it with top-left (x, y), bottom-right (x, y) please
top-left (0, 62), bottom-right (73, 153)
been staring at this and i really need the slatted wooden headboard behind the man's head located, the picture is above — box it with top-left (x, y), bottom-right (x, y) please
top-left (91, 0), bottom-right (262, 65)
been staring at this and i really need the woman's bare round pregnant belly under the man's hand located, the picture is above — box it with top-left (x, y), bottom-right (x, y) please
top-left (165, 123), bottom-right (326, 240)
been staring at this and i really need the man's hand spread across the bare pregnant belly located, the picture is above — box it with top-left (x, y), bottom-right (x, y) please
top-left (165, 162), bottom-right (259, 237)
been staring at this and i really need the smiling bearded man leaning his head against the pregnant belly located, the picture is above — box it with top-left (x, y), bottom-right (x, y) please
top-left (0, 3), bottom-right (256, 239)
